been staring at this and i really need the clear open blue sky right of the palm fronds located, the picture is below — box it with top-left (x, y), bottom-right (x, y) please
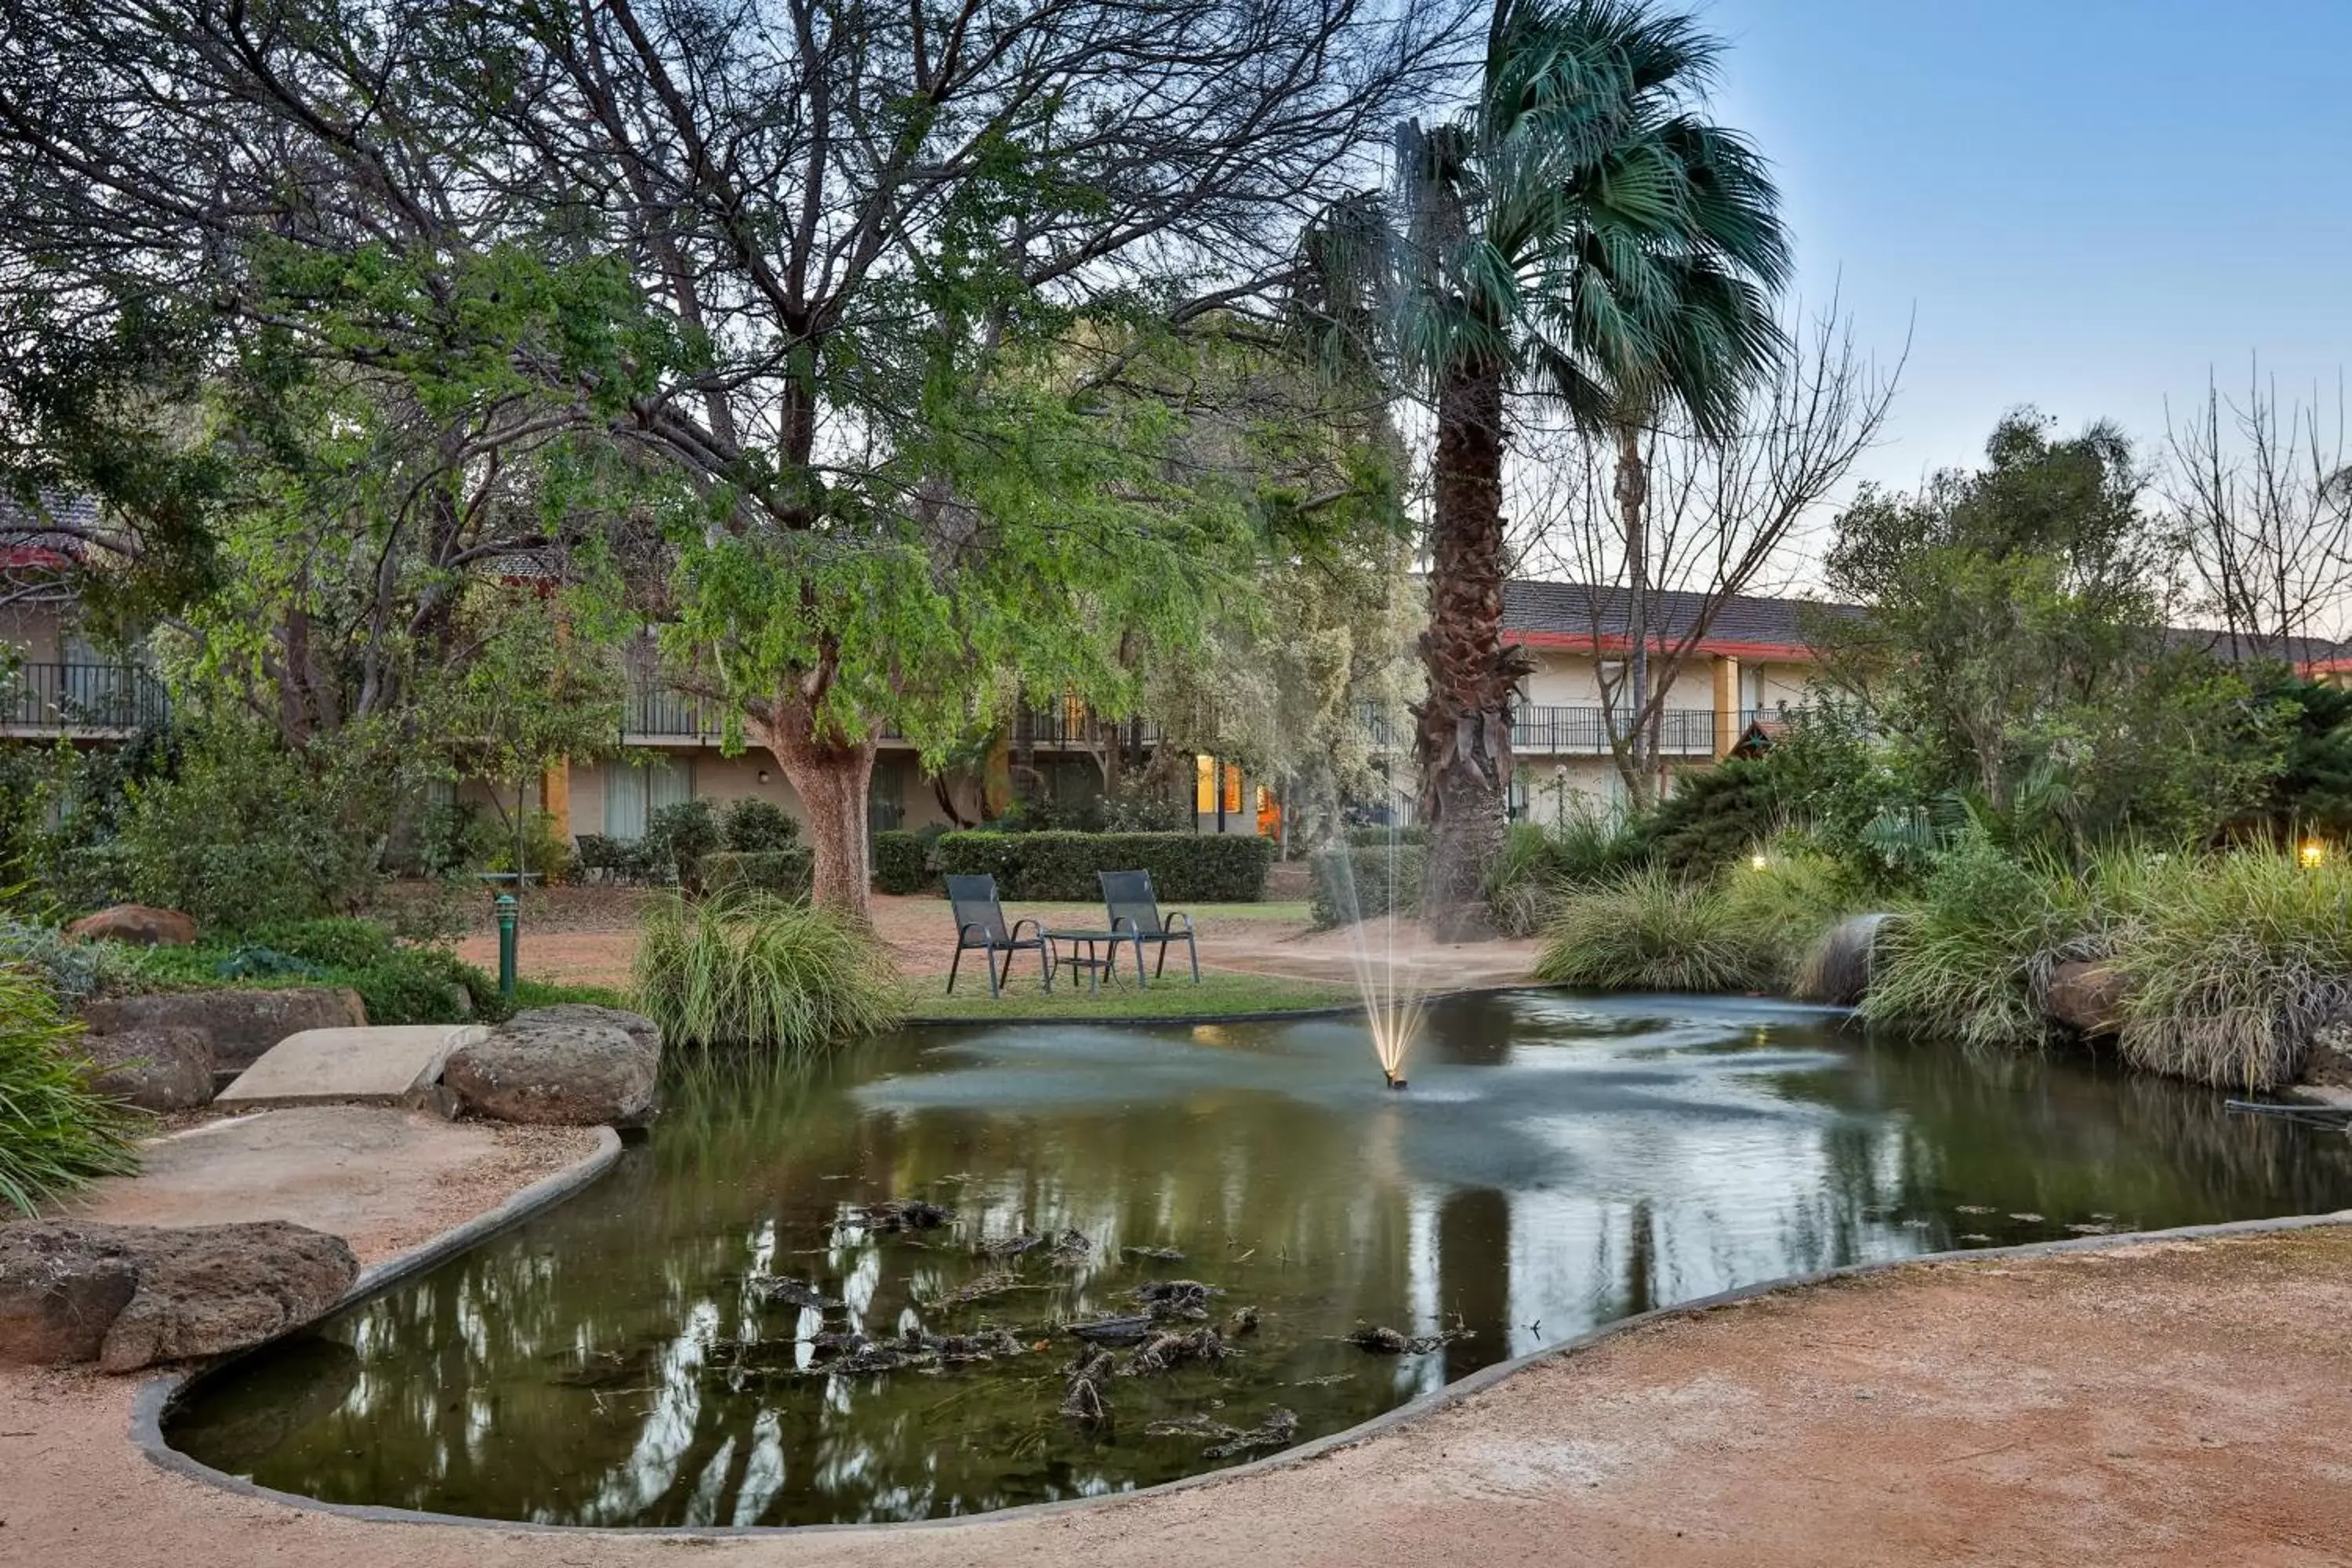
top-left (1698, 0), bottom-right (2352, 487)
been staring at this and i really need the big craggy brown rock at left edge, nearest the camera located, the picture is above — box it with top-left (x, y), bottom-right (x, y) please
top-left (0, 1220), bottom-right (360, 1373)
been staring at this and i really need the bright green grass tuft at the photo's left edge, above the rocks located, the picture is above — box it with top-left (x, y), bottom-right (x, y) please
top-left (0, 966), bottom-right (139, 1213)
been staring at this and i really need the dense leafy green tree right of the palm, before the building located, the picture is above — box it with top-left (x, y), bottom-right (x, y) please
top-left (1811, 414), bottom-right (2281, 844)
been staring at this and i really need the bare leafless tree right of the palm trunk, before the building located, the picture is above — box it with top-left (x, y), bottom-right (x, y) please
top-left (1515, 301), bottom-right (1907, 806)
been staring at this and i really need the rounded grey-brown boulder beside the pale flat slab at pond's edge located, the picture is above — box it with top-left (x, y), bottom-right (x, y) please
top-left (442, 1001), bottom-right (661, 1126)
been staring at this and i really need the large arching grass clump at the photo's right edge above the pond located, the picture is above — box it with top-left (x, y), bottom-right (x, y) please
top-left (2096, 848), bottom-right (2352, 1088)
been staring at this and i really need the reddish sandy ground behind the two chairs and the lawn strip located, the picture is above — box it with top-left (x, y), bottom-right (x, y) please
top-left (459, 888), bottom-right (1538, 989)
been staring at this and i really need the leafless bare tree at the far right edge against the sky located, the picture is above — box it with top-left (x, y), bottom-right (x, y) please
top-left (2159, 369), bottom-right (2352, 656)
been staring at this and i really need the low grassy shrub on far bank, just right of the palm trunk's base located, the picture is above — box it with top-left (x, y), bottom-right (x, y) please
top-left (1536, 865), bottom-right (1769, 992)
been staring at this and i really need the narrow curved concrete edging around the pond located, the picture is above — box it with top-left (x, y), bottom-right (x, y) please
top-left (129, 1128), bottom-right (2352, 1540)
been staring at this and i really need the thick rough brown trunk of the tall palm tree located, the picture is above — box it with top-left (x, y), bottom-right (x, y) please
top-left (1414, 365), bottom-right (1529, 938)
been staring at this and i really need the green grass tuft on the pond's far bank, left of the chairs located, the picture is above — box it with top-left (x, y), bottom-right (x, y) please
top-left (637, 893), bottom-right (903, 1055)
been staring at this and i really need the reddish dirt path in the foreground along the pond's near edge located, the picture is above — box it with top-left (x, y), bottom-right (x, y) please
top-left (0, 1229), bottom-right (2352, 1568)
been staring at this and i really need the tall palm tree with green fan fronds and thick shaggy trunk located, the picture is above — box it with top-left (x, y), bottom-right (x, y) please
top-left (1298, 0), bottom-right (1790, 926)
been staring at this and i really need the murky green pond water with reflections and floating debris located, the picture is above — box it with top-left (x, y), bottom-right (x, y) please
top-left (167, 992), bottom-right (2352, 1526)
